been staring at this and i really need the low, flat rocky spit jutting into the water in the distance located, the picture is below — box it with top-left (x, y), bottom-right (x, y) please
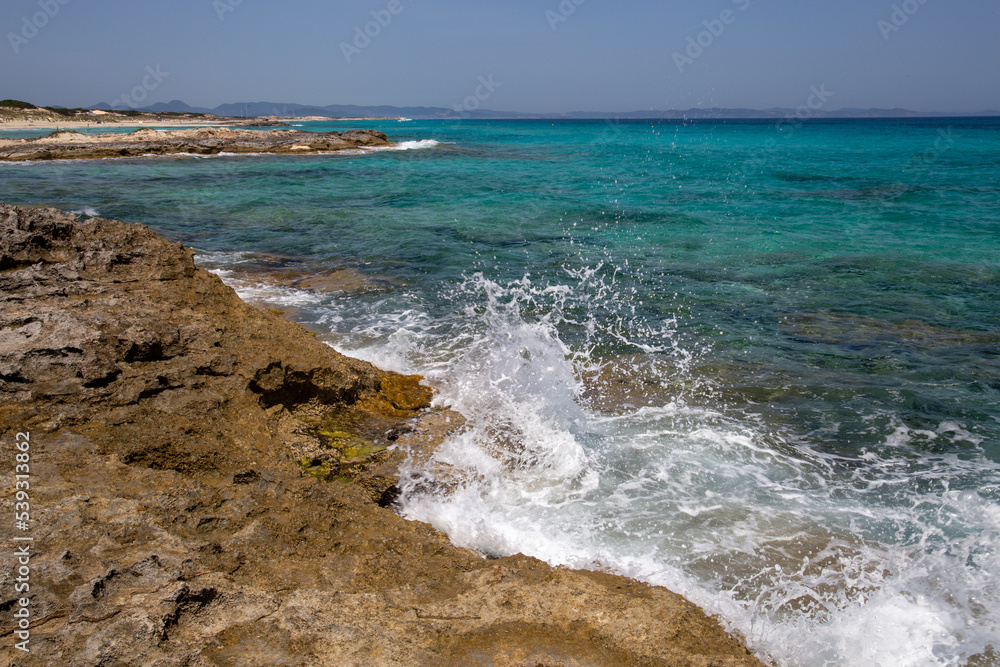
top-left (0, 127), bottom-right (392, 162)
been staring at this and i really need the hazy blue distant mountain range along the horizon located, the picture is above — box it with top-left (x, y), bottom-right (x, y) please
top-left (90, 100), bottom-right (1000, 120)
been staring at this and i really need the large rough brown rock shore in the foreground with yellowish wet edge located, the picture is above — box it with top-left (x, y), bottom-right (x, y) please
top-left (0, 206), bottom-right (760, 667)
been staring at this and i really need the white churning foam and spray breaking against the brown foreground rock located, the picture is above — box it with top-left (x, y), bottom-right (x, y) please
top-left (207, 258), bottom-right (1000, 666)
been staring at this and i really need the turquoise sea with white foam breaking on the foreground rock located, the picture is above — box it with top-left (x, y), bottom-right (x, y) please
top-left (0, 119), bottom-right (1000, 666)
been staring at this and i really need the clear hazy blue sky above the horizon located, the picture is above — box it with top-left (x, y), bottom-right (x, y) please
top-left (0, 0), bottom-right (1000, 113)
